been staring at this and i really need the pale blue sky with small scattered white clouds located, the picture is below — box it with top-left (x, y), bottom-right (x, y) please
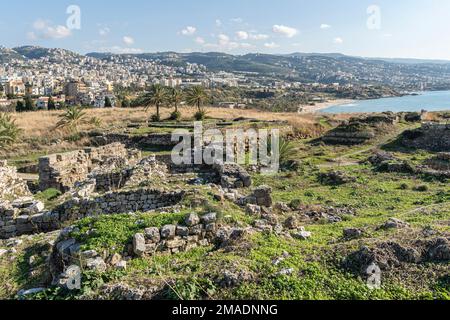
top-left (0, 0), bottom-right (450, 60)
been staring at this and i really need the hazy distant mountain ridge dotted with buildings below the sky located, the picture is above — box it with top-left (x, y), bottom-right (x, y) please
top-left (0, 46), bottom-right (450, 90)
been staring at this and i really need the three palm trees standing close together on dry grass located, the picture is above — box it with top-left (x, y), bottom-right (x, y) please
top-left (137, 84), bottom-right (209, 122)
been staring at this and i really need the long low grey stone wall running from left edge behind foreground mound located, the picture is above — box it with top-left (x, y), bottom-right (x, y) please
top-left (0, 189), bottom-right (184, 239)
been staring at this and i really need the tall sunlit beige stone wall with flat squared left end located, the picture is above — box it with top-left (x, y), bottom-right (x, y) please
top-left (39, 143), bottom-right (141, 192)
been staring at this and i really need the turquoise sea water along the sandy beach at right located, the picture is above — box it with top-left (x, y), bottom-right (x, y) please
top-left (321, 91), bottom-right (450, 113)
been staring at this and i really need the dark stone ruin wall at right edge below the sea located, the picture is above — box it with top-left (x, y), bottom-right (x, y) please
top-left (400, 123), bottom-right (450, 152)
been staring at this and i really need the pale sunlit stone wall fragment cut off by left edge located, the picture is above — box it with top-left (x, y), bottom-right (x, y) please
top-left (0, 160), bottom-right (31, 200)
